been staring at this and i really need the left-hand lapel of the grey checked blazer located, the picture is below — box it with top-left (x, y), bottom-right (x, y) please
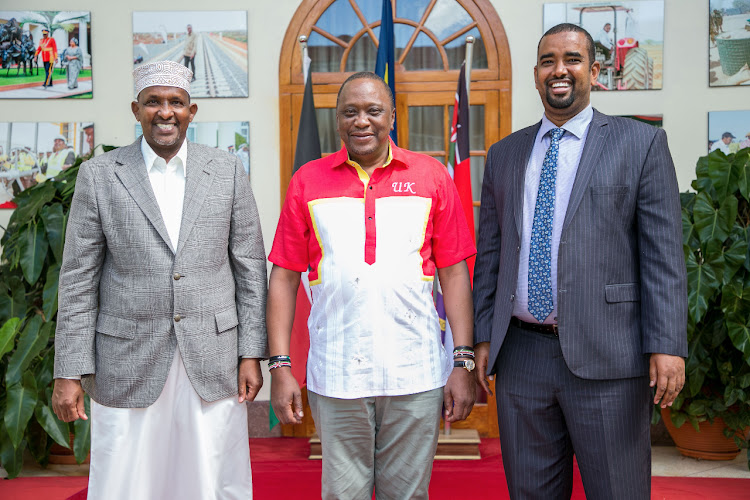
top-left (115, 139), bottom-right (174, 252)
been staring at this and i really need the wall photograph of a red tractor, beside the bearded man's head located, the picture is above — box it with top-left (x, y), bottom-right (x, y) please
top-left (544, 0), bottom-right (664, 90)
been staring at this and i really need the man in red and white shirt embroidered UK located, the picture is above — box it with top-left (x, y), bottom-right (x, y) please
top-left (267, 73), bottom-right (476, 499)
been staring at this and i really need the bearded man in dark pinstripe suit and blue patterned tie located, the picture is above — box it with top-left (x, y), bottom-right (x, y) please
top-left (474, 24), bottom-right (687, 499)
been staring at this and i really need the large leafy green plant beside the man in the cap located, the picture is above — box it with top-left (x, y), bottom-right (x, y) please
top-left (0, 148), bottom-right (111, 478)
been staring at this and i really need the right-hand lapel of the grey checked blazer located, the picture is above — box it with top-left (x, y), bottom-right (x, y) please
top-left (177, 142), bottom-right (215, 252)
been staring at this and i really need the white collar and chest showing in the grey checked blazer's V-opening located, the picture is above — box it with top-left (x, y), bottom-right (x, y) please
top-left (141, 139), bottom-right (187, 251)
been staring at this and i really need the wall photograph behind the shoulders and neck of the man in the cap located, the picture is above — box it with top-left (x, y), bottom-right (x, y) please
top-left (135, 122), bottom-right (250, 175)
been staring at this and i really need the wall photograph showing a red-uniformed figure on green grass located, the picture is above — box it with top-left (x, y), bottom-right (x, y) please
top-left (0, 10), bottom-right (93, 99)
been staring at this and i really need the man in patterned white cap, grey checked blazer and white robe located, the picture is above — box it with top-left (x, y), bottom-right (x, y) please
top-left (53, 61), bottom-right (267, 499)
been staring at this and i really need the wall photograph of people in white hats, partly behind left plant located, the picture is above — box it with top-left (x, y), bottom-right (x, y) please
top-left (0, 122), bottom-right (95, 207)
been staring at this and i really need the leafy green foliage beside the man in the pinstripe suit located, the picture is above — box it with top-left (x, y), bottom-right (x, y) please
top-left (657, 148), bottom-right (750, 468)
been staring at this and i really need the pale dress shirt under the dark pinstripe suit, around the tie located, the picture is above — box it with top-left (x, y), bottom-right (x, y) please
top-left (513, 105), bottom-right (594, 324)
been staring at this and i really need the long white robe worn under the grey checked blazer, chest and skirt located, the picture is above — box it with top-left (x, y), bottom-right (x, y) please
top-left (88, 140), bottom-right (252, 500)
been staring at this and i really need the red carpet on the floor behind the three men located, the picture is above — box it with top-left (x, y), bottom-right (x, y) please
top-left (0, 438), bottom-right (750, 500)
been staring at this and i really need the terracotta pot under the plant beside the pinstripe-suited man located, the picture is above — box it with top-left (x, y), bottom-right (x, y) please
top-left (661, 408), bottom-right (740, 460)
